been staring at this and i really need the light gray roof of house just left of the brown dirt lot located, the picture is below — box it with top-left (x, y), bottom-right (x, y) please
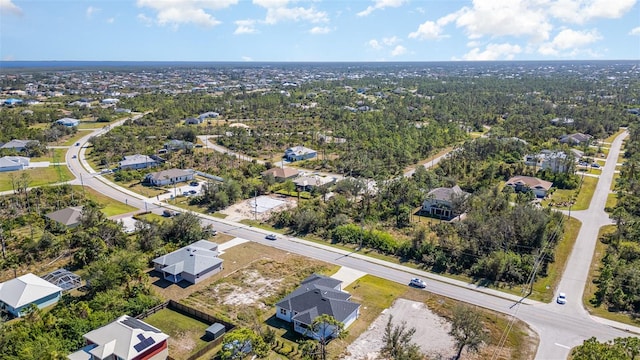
top-left (153, 240), bottom-right (222, 275)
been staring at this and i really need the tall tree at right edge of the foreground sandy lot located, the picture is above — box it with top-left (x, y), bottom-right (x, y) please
top-left (449, 304), bottom-right (487, 360)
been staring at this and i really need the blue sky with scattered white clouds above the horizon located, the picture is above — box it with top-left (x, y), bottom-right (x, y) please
top-left (0, 0), bottom-right (640, 61)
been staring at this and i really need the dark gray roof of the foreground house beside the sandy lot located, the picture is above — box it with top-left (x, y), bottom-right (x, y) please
top-left (276, 274), bottom-right (360, 325)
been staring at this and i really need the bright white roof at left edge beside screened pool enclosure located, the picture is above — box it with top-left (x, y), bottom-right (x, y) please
top-left (0, 273), bottom-right (62, 309)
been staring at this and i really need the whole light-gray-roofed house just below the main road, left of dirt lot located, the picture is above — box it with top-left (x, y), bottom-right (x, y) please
top-left (153, 240), bottom-right (223, 284)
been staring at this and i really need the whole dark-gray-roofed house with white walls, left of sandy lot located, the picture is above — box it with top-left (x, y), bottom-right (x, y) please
top-left (276, 274), bottom-right (360, 339)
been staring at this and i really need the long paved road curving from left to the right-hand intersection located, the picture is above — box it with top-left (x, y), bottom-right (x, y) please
top-left (67, 124), bottom-right (640, 360)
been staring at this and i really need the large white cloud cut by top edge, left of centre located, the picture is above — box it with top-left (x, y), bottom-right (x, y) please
top-left (137, 0), bottom-right (238, 27)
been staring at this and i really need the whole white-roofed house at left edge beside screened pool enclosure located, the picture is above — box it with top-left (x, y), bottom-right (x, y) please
top-left (0, 273), bottom-right (62, 317)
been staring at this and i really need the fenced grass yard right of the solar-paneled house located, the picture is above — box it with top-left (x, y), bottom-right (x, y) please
top-left (144, 308), bottom-right (209, 359)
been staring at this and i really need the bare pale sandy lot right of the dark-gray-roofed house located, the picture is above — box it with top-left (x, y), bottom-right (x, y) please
top-left (344, 299), bottom-right (456, 360)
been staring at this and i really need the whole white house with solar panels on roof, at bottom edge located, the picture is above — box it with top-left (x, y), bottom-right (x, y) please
top-left (67, 315), bottom-right (169, 360)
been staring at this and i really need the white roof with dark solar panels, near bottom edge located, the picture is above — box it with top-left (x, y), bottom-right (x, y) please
top-left (84, 315), bottom-right (169, 360)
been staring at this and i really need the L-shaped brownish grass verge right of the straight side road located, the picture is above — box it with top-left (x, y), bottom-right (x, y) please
top-left (582, 225), bottom-right (640, 326)
